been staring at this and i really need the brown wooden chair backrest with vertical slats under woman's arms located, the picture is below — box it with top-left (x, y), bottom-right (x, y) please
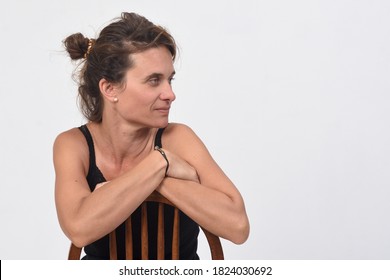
top-left (68, 192), bottom-right (224, 260)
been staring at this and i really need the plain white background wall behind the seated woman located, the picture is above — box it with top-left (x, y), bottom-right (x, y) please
top-left (0, 0), bottom-right (390, 259)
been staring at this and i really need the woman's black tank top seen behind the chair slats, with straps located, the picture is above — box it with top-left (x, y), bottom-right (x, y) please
top-left (79, 125), bottom-right (199, 260)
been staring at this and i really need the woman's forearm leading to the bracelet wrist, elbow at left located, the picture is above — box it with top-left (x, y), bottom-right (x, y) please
top-left (60, 152), bottom-right (166, 246)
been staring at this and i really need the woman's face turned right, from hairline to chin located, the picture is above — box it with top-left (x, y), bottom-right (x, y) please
top-left (116, 47), bottom-right (176, 127)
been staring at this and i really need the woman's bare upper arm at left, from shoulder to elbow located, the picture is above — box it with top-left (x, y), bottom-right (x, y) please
top-left (53, 129), bottom-right (91, 235)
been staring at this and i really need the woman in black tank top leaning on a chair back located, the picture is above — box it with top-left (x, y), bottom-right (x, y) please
top-left (54, 13), bottom-right (249, 259)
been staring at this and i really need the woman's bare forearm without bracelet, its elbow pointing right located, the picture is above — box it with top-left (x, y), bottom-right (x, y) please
top-left (156, 178), bottom-right (249, 243)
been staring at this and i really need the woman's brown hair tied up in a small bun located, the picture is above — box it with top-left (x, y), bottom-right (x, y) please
top-left (63, 13), bottom-right (176, 122)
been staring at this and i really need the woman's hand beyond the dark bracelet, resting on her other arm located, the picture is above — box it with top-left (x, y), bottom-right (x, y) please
top-left (164, 150), bottom-right (199, 183)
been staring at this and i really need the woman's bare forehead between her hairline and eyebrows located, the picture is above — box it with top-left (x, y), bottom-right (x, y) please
top-left (129, 47), bottom-right (174, 76)
